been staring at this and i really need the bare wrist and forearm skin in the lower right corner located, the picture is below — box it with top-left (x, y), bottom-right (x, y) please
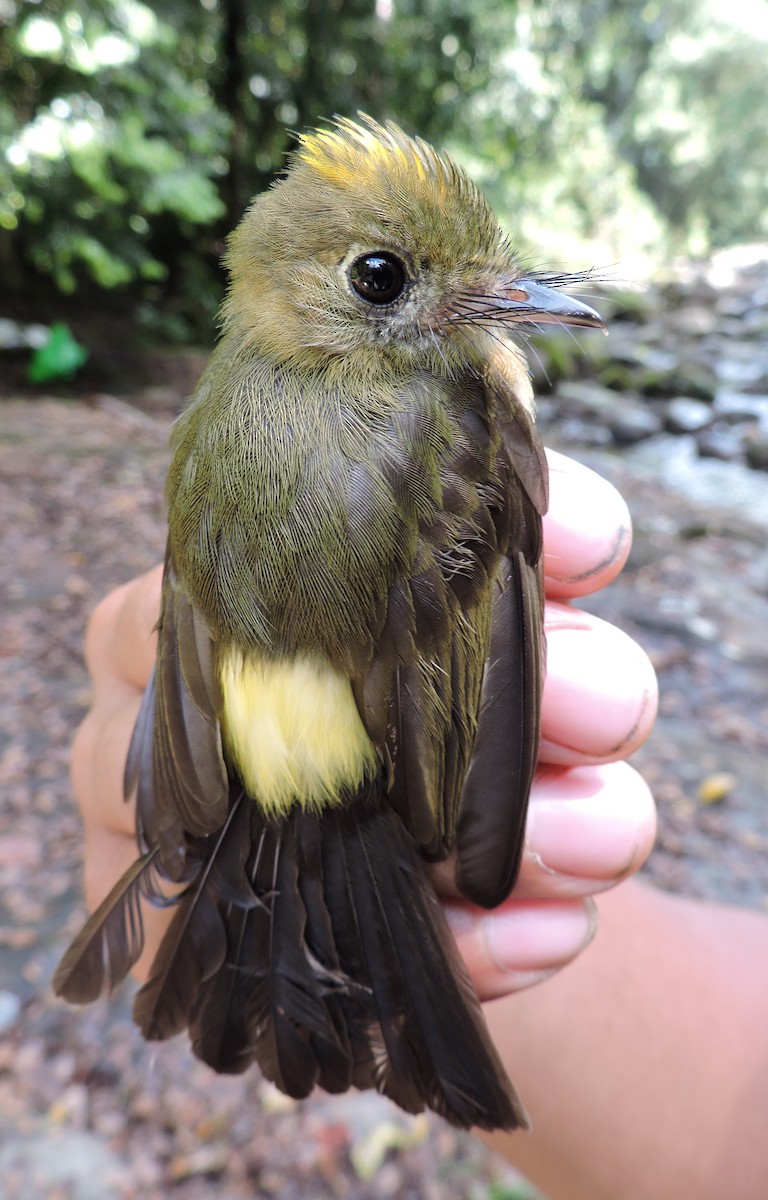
top-left (479, 880), bottom-right (768, 1200)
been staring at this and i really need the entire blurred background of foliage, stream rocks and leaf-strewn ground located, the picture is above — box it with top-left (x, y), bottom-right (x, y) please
top-left (0, 0), bottom-right (768, 1200)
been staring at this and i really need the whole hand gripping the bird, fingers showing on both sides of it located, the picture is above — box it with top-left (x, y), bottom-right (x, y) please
top-left (72, 454), bottom-right (656, 1000)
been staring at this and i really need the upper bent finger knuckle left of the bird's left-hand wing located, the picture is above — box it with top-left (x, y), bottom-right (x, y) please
top-left (85, 566), bottom-right (162, 690)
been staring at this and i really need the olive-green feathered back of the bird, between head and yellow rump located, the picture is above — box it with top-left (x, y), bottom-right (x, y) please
top-left (168, 360), bottom-right (492, 673)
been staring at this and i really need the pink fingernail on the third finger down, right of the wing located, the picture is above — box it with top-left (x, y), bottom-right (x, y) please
top-left (526, 763), bottom-right (654, 887)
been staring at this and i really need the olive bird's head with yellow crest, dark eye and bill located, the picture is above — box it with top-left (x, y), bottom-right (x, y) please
top-left (224, 116), bottom-right (602, 374)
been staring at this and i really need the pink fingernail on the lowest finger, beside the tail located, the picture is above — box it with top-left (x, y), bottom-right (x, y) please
top-left (482, 898), bottom-right (598, 986)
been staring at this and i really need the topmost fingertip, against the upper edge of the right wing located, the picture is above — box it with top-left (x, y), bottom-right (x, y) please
top-left (544, 450), bottom-right (632, 599)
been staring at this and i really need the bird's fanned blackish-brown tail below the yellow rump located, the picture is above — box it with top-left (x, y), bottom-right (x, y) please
top-left (59, 785), bottom-right (527, 1129)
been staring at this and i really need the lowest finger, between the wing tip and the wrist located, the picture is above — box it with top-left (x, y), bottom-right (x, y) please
top-left (445, 899), bottom-right (596, 1000)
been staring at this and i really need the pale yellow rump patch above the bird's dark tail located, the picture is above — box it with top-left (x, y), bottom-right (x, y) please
top-left (220, 649), bottom-right (378, 816)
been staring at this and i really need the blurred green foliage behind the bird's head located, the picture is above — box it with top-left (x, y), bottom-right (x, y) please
top-left (0, 0), bottom-right (768, 336)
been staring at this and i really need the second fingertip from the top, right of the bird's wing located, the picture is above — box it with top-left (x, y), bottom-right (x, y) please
top-left (539, 602), bottom-right (659, 767)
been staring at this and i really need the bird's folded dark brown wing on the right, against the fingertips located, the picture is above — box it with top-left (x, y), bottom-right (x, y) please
top-left (354, 369), bottom-right (546, 902)
